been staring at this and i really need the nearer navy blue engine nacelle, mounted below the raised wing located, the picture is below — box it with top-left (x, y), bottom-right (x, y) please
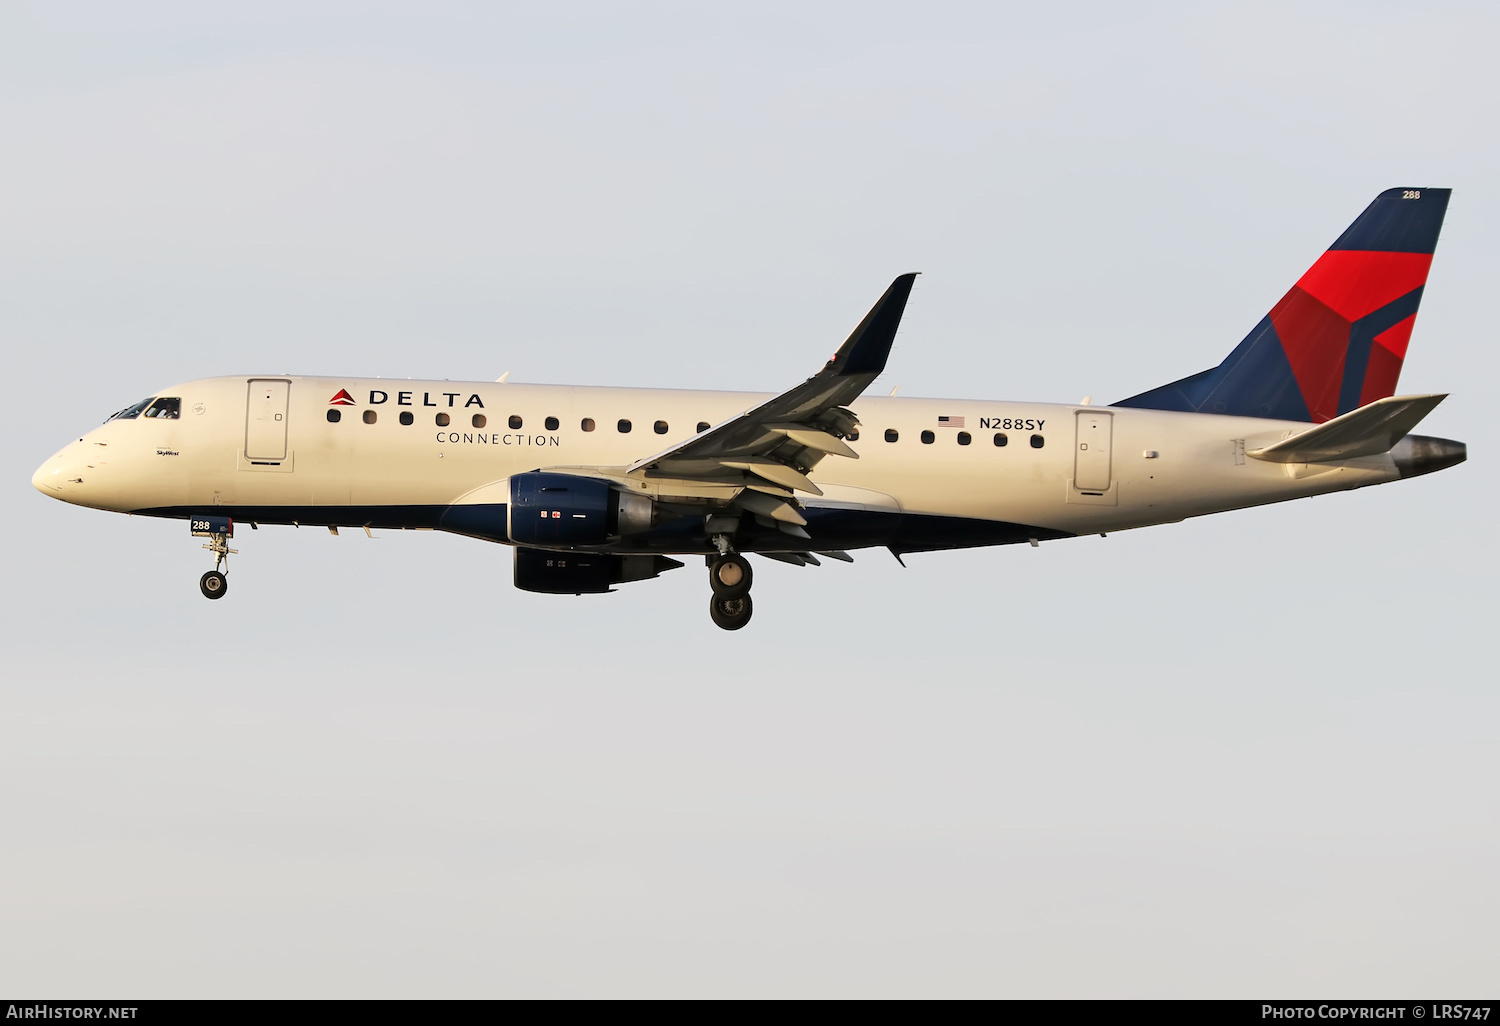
top-left (507, 471), bottom-right (654, 549)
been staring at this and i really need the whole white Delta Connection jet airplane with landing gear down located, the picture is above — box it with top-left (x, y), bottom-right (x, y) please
top-left (32, 189), bottom-right (1467, 630)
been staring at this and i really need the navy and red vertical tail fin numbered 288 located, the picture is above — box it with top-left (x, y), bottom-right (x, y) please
top-left (1115, 189), bottom-right (1452, 423)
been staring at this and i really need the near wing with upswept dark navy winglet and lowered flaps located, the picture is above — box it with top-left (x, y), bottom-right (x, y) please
top-left (624, 273), bottom-right (917, 537)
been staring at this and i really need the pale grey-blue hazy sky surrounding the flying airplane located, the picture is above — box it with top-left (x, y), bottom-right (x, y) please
top-left (0, 3), bottom-right (1500, 996)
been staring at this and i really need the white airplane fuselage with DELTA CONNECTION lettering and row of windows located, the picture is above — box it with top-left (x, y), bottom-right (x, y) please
top-left (33, 375), bottom-right (1436, 554)
